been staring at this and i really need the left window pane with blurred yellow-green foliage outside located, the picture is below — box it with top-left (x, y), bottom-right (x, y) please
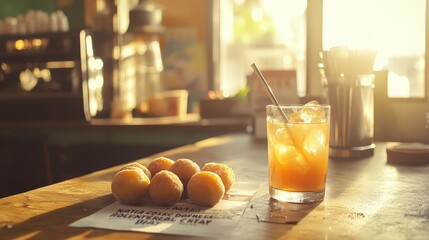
top-left (218, 0), bottom-right (307, 96)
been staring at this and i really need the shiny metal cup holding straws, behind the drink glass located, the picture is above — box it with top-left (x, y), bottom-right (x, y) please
top-left (326, 74), bottom-right (375, 158)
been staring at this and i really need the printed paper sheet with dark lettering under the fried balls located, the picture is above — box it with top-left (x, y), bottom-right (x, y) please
top-left (70, 183), bottom-right (259, 237)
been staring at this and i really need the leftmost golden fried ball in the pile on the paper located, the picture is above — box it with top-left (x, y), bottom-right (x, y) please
top-left (111, 167), bottom-right (150, 205)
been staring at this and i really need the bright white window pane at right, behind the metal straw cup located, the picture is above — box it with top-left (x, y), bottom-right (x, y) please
top-left (322, 0), bottom-right (426, 98)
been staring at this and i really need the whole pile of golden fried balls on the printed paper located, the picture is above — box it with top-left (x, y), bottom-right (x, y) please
top-left (111, 157), bottom-right (235, 207)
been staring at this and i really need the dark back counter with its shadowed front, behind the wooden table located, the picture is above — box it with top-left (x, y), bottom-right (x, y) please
top-left (0, 113), bottom-right (252, 195)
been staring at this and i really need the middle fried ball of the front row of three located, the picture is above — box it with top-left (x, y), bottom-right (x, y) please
top-left (149, 170), bottom-right (183, 206)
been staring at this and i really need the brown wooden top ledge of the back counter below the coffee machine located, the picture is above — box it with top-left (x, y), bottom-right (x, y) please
top-left (0, 114), bottom-right (252, 146)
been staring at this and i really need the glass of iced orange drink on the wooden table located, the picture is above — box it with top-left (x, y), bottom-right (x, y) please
top-left (267, 102), bottom-right (330, 202)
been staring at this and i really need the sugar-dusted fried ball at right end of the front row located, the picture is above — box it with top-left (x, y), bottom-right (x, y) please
top-left (187, 171), bottom-right (225, 207)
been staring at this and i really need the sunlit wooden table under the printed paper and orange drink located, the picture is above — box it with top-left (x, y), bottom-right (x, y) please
top-left (0, 134), bottom-right (429, 239)
